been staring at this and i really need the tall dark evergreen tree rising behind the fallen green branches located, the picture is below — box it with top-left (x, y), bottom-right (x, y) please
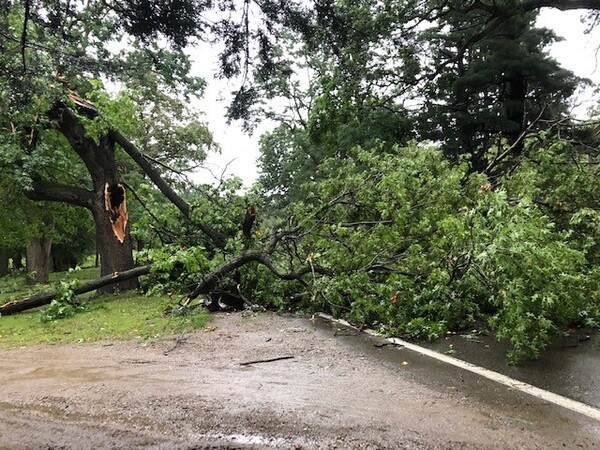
top-left (419, 12), bottom-right (582, 172)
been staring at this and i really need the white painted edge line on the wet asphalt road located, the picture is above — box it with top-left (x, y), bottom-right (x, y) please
top-left (319, 313), bottom-right (600, 421)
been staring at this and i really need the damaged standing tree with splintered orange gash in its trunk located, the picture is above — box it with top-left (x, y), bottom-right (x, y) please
top-left (0, 0), bottom-right (308, 289)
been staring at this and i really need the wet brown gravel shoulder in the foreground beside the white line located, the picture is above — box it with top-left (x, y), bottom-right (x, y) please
top-left (0, 313), bottom-right (600, 450)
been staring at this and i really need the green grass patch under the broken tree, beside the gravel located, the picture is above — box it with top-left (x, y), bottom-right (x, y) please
top-left (0, 269), bottom-right (210, 348)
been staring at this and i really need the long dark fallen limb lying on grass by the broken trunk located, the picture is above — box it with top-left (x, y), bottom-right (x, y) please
top-left (0, 265), bottom-right (152, 316)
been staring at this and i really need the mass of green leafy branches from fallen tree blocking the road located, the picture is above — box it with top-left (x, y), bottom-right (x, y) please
top-left (261, 141), bottom-right (600, 362)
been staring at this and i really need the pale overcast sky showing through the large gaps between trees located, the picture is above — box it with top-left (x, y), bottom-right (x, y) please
top-left (194, 8), bottom-right (600, 187)
